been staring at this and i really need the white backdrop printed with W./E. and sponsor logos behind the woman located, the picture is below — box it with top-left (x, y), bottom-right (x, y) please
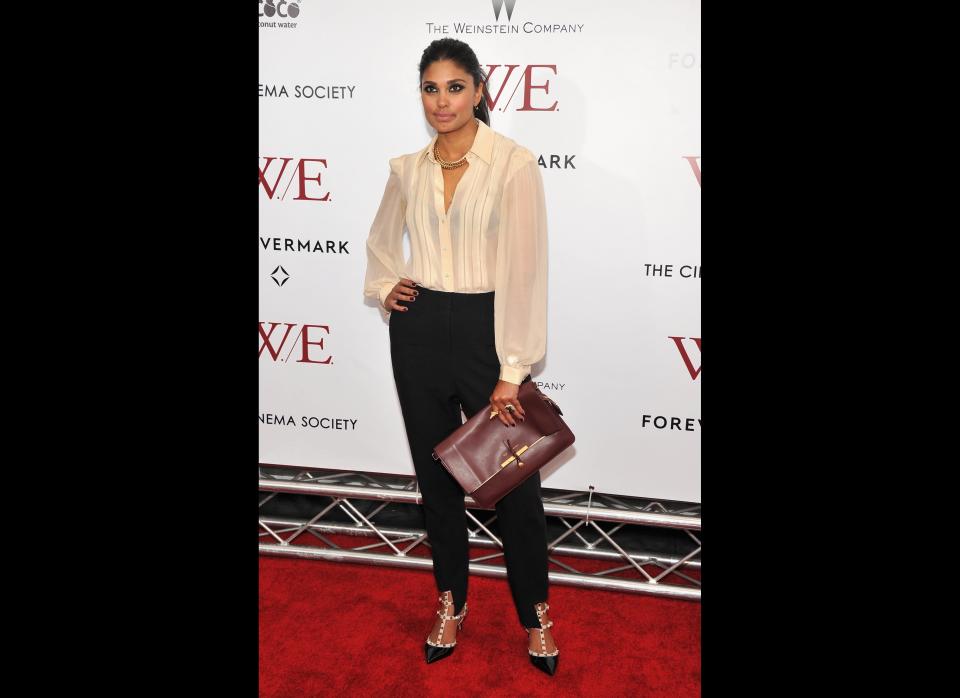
top-left (259, 0), bottom-right (701, 502)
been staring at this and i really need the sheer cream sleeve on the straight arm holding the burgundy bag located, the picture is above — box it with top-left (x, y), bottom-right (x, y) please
top-left (494, 152), bottom-right (547, 384)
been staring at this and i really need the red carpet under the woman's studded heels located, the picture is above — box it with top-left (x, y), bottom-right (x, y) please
top-left (260, 540), bottom-right (701, 698)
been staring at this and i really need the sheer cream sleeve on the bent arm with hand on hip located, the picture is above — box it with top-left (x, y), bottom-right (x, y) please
top-left (363, 157), bottom-right (405, 314)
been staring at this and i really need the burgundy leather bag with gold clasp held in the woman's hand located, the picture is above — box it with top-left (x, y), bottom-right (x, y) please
top-left (433, 381), bottom-right (574, 509)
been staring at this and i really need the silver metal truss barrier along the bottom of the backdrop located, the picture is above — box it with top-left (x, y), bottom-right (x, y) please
top-left (259, 464), bottom-right (701, 601)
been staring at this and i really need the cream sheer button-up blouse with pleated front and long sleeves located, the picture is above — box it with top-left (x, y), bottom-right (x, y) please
top-left (364, 119), bottom-right (547, 384)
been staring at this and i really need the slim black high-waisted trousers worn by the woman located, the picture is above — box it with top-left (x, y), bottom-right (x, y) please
top-left (390, 286), bottom-right (547, 628)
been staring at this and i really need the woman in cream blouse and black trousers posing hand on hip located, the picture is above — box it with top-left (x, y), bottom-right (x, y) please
top-left (364, 38), bottom-right (559, 676)
